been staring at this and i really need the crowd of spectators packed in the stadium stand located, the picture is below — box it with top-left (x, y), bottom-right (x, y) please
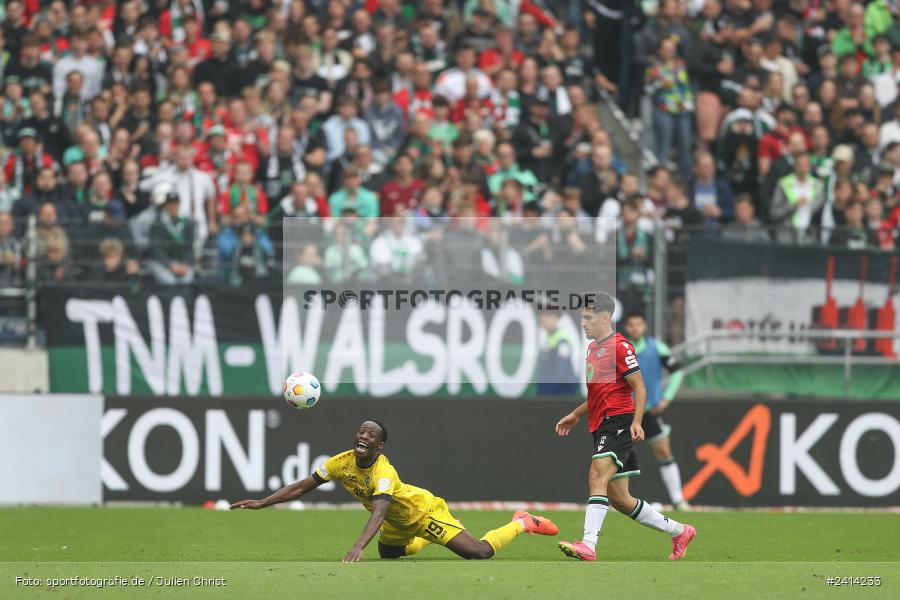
top-left (0, 0), bottom-right (900, 286)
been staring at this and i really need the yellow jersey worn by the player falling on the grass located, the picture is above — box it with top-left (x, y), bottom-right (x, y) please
top-left (316, 450), bottom-right (435, 525)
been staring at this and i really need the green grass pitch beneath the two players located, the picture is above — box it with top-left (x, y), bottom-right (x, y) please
top-left (0, 508), bottom-right (900, 600)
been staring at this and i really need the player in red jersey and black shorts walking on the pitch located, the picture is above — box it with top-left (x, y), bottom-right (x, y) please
top-left (556, 292), bottom-right (697, 561)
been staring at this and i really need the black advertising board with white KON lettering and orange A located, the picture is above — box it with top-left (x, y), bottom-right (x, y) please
top-left (101, 397), bottom-right (900, 507)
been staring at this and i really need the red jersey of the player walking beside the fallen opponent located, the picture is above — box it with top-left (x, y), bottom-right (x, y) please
top-left (585, 333), bottom-right (641, 432)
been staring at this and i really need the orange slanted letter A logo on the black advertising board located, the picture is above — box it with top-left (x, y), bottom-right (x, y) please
top-left (683, 404), bottom-right (772, 500)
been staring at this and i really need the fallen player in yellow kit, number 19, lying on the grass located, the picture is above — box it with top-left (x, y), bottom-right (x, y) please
top-left (231, 420), bottom-right (559, 562)
